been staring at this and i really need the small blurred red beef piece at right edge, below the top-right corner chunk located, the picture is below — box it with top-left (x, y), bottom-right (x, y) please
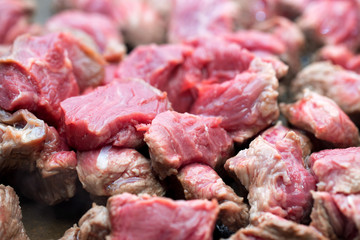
top-left (318, 45), bottom-right (360, 74)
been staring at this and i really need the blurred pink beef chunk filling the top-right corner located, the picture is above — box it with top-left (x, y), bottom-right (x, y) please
top-left (298, 0), bottom-right (360, 50)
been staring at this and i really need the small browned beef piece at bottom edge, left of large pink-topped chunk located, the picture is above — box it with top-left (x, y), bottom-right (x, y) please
top-left (59, 204), bottom-right (111, 240)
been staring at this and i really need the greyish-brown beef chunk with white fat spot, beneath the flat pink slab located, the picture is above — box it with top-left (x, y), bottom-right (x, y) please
top-left (76, 146), bottom-right (165, 196)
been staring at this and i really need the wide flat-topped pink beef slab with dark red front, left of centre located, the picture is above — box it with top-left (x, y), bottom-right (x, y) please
top-left (61, 79), bottom-right (171, 151)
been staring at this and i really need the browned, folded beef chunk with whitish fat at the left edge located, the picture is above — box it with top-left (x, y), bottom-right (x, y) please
top-left (0, 110), bottom-right (77, 205)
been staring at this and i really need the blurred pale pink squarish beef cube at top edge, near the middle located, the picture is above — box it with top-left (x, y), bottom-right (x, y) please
top-left (168, 0), bottom-right (235, 42)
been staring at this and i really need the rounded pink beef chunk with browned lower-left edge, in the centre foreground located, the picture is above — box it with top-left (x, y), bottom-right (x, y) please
top-left (144, 111), bottom-right (233, 179)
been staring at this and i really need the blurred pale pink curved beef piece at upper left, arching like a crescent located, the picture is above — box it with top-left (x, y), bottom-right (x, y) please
top-left (46, 10), bottom-right (126, 62)
